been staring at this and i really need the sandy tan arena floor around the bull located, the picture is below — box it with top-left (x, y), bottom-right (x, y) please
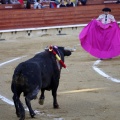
top-left (0, 32), bottom-right (120, 120)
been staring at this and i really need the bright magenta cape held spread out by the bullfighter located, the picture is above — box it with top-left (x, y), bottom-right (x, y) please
top-left (79, 20), bottom-right (120, 59)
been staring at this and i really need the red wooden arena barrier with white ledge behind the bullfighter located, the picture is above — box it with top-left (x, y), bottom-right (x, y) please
top-left (0, 0), bottom-right (120, 38)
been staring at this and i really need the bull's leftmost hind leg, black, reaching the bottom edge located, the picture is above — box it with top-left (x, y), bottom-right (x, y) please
top-left (13, 94), bottom-right (25, 120)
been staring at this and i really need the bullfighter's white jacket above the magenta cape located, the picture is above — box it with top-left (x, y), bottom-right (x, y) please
top-left (96, 14), bottom-right (116, 24)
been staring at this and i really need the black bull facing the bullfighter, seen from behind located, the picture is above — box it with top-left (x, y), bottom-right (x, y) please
top-left (11, 47), bottom-right (71, 120)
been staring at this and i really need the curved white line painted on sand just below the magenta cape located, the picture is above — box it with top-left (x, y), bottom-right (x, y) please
top-left (92, 60), bottom-right (120, 83)
